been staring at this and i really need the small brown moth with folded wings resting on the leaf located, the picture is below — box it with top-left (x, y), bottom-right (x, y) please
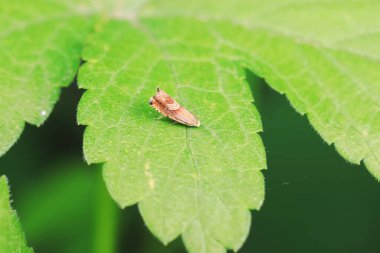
top-left (149, 88), bottom-right (201, 127)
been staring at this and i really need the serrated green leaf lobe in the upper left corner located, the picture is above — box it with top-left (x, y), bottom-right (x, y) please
top-left (0, 0), bottom-right (91, 155)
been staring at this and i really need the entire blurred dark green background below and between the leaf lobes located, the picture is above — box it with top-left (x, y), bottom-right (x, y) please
top-left (0, 73), bottom-right (380, 253)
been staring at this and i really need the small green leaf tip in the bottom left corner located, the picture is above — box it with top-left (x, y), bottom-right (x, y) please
top-left (0, 176), bottom-right (33, 253)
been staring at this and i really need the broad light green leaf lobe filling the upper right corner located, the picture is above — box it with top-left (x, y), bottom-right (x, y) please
top-left (143, 0), bottom-right (380, 179)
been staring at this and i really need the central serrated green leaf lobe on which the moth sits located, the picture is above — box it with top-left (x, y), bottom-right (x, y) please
top-left (78, 18), bottom-right (266, 253)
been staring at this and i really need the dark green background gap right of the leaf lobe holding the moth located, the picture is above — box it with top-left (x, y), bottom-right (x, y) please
top-left (241, 70), bottom-right (380, 253)
